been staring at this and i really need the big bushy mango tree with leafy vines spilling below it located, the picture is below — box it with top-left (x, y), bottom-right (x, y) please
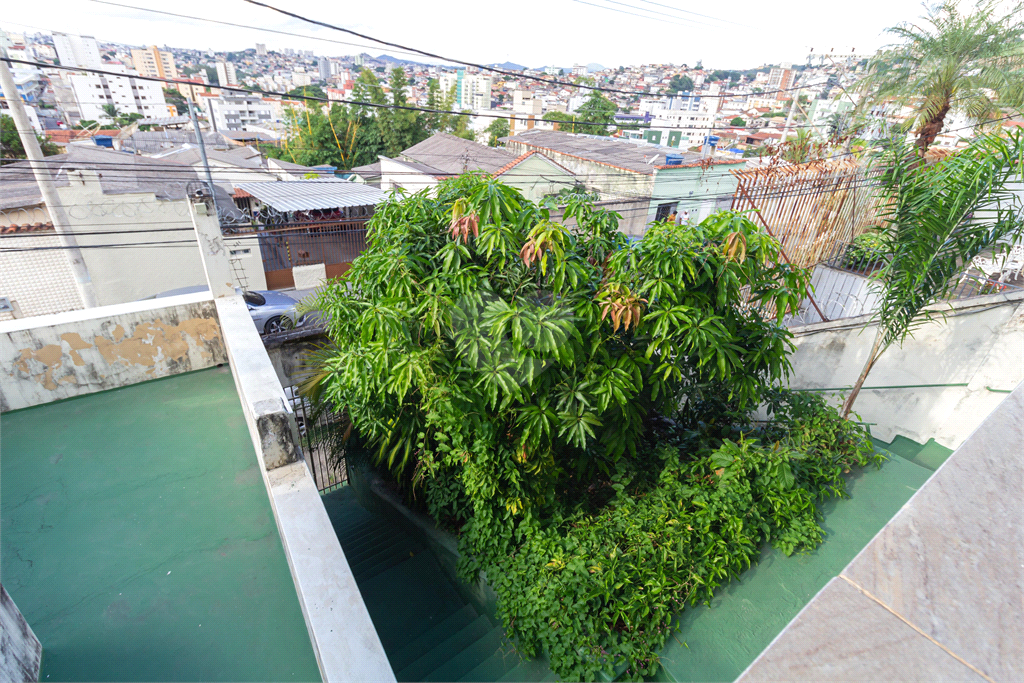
top-left (305, 174), bottom-right (870, 680)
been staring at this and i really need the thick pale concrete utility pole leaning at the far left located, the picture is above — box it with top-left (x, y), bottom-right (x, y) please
top-left (0, 46), bottom-right (99, 308)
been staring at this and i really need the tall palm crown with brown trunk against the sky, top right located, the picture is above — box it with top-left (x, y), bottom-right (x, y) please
top-left (858, 0), bottom-right (1024, 157)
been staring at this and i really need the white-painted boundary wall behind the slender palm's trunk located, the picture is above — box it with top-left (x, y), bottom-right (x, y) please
top-left (790, 294), bottom-right (1024, 449)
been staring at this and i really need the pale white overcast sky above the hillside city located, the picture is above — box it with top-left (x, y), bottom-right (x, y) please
top-left (0, 0), bottom-right (937, 69)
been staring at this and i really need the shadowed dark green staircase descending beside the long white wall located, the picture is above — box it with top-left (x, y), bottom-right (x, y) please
top-left (324, 486), bottom-right (557, 681)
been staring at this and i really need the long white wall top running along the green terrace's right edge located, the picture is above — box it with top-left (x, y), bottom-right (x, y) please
top-left (216, 296), bottom-right (395, 682)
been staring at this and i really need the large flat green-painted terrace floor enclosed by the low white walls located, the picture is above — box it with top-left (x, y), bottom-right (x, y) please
top-left (0, 368), bottom-right (319, 681)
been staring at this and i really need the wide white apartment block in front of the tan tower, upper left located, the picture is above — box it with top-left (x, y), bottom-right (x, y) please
top-left (71, 65), bottom-right (171, 121)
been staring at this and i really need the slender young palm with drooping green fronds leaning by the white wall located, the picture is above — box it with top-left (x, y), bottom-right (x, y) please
top-left (843, 133), bottom-right (1024, 417)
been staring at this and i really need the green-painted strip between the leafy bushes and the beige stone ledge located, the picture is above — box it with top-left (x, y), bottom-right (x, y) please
top-left (654, 436), bottom-right (952, 681)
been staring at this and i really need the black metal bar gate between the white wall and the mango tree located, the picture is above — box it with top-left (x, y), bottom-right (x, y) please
top-left (285, 386), bottom-right (348, 494)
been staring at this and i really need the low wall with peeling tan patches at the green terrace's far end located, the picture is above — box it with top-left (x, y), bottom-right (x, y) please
top-left (0, 293), bottom-right (225, 412)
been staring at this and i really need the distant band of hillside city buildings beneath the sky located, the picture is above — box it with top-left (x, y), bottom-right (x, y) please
top-left (0, 33), bottom-right (971, 161)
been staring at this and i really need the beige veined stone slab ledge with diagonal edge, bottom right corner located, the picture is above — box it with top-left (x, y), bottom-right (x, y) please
top-left (737, 383), bottom-right (1024, 683)
